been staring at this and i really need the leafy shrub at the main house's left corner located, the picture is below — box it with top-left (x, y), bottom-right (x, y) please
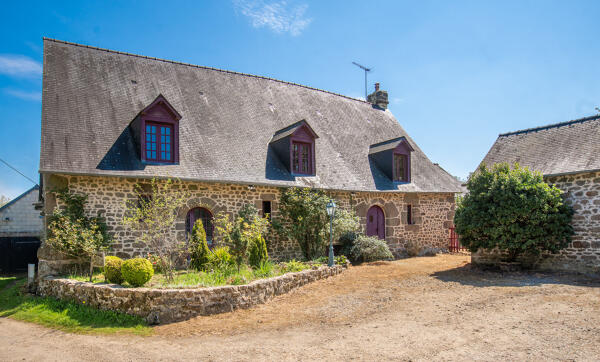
top-left (45, 188), bottom-right (111, 281)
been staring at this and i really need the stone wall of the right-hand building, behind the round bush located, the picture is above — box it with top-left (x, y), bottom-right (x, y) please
top-left (471, 172), bottom-right (600, 273)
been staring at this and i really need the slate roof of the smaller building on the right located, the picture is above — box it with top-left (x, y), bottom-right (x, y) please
top-left (482, 115), bottom-right (600, 176)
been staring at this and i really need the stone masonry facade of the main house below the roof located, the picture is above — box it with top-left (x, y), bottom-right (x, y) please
top-left (44, 175), bottom-right (455, 260)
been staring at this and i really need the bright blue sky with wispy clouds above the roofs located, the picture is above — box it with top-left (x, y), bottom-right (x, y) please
top-left (0, 0), bottom-right (600, 198)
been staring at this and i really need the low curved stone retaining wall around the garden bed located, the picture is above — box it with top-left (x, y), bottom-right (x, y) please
top-left (37, 265), bottom-right (345, 324)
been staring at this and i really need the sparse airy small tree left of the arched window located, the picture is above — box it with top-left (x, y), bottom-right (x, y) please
top-left (123, 178), bottom-right (188, 280)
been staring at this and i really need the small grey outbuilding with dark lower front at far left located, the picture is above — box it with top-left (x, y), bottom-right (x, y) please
top-left (0, 185), bottom-right (44, 272)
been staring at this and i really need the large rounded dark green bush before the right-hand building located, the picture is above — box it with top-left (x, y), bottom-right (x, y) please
top-left (454, 163), bottom-right (573, 261)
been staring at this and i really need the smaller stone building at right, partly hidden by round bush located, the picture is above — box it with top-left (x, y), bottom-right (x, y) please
top-left (472, 115), bottom-right (600, 272)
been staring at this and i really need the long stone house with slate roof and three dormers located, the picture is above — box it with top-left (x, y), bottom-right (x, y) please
top-left (40, 39), bottom-right (460, 266)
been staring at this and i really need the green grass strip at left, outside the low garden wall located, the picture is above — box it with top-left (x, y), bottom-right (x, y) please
top-left (0, 278), bottom-right (152, 335)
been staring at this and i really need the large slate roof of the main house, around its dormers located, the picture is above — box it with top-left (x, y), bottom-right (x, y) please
top-left (40, 38), bottom-right (460, 192)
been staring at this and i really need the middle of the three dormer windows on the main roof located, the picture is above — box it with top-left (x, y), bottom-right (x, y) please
top-left (269, 120), bottom-right (318, 176)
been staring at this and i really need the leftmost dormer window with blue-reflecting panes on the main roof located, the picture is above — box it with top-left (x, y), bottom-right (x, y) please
top-left (132, 95), bottom-right (181, 164)
